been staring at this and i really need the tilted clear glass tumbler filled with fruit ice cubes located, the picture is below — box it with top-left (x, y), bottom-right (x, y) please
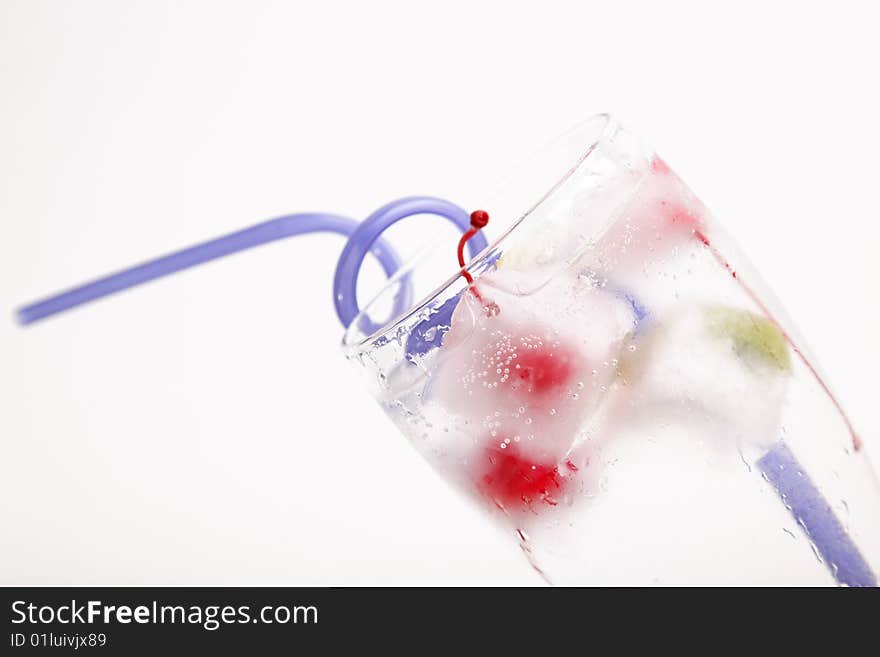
top-left (344, 116), bottom-right (880, 586)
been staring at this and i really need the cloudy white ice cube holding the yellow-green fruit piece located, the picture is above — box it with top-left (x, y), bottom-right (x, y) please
top-left (615, 304), bottom-right (790, 446)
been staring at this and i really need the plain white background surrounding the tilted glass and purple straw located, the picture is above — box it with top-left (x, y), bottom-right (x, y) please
top-left (0, 0), bottom-right (880, 585)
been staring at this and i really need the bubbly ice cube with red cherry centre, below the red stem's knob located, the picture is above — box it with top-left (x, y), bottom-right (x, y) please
top-left (430, 270), bottom-right (633, 463)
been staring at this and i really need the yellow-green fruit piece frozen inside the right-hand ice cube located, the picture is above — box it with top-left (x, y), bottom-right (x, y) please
top-left (706, 306), bottom-right (791, 372)
